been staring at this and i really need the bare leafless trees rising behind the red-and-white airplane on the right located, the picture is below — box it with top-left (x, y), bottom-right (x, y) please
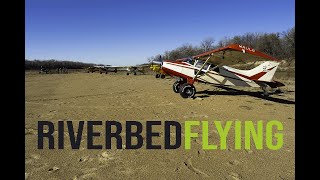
top-left (148, 27), bottom-right (295, 62)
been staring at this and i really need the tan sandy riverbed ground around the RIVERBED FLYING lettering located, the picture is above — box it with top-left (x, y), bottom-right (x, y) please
top-left (25, 73), bottom-right (295, 179)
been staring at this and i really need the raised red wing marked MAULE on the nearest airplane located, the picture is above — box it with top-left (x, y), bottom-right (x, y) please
top-left (193, 44), bottom-right (279, 65)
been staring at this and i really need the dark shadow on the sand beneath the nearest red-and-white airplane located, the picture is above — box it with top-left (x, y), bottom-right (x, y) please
top-left (196, 86), bottom-right (295, 104)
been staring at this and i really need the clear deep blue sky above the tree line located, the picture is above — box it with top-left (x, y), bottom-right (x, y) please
top-left (25, 0), bottom-right (295, 66)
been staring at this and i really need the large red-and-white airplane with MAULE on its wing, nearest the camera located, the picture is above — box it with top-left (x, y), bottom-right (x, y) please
top-left (161, 44), bottom-right (285, 98)
